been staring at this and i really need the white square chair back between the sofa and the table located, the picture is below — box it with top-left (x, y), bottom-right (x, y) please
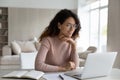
top-left (20, 51), bottom-right (37, 69)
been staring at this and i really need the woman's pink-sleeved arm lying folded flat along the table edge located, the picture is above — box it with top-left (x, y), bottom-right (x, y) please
top-left (35, 46), bottom-right (71, 72)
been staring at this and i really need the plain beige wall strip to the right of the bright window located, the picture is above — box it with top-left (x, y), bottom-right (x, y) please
top-left (107, 0), bottom-right (120, 68)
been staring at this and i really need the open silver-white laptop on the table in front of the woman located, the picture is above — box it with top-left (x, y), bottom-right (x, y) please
top-left (64, 52), bottom-right (117, 79)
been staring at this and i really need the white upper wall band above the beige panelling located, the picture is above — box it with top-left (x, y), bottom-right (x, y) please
top-left (0, 0), bottom-right (77, 9)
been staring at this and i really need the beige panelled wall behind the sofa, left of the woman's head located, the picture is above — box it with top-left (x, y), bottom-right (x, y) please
top-left (8, 8), bottom-right (76, 43)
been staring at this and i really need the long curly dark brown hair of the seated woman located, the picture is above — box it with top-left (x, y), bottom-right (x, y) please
top-left (39, 9), bottom-right (81, 41)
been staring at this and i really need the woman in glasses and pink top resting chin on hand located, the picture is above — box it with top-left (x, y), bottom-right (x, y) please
top-left (35, 9), bottom-right (81, 72)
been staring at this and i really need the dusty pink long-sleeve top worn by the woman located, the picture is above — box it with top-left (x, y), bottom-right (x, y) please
top-left (35, 37), bottom-right (79, 72)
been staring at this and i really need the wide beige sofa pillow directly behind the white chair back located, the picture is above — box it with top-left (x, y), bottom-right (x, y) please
top-left (17, 41), bottom-right (37, 52)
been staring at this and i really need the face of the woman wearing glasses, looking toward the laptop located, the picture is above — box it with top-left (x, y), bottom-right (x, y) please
top-left (58, 17), bottom-right (76, 37)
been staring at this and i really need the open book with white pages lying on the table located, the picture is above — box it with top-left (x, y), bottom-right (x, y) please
top-left (2, 70), bottom-right (45, 80)
